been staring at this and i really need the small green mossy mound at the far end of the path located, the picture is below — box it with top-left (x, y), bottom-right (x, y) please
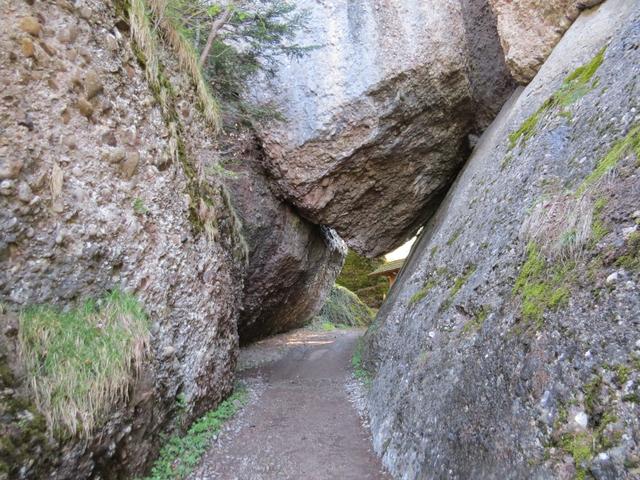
top-left (312, 285), bottom-right (373, 331)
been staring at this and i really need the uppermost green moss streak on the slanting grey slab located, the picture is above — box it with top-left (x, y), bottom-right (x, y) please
top-left (507, 47), bottom-right (606, 150)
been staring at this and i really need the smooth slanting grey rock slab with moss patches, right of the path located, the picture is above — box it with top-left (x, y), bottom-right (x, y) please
top-left (365, 0), bottom-right (640, 479)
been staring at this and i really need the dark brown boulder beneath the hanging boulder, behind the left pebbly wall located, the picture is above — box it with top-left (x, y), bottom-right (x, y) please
top-left (222, 133), bottom-right (346, 343)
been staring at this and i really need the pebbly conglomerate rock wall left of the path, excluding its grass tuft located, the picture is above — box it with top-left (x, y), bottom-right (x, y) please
top-left (0, 0), bottom-right (243, 479)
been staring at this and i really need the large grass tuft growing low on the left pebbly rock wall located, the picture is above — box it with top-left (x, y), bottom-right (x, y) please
top-left (19, 290), bottom-right (149, 436)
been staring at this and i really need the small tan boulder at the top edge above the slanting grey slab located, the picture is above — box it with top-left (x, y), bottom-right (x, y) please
top-left (489, 0), bottom-right (603, 85)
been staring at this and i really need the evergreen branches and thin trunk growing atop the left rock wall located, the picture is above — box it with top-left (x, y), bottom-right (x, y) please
top-left (152, 0), bottom-right (315, 122)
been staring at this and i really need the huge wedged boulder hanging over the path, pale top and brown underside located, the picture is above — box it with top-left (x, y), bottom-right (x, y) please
top-left (252, 0), bottom-right (513, 256)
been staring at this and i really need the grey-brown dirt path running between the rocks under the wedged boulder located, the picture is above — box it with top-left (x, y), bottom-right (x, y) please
top-left (190, 330), bottom-right (389, 480)
